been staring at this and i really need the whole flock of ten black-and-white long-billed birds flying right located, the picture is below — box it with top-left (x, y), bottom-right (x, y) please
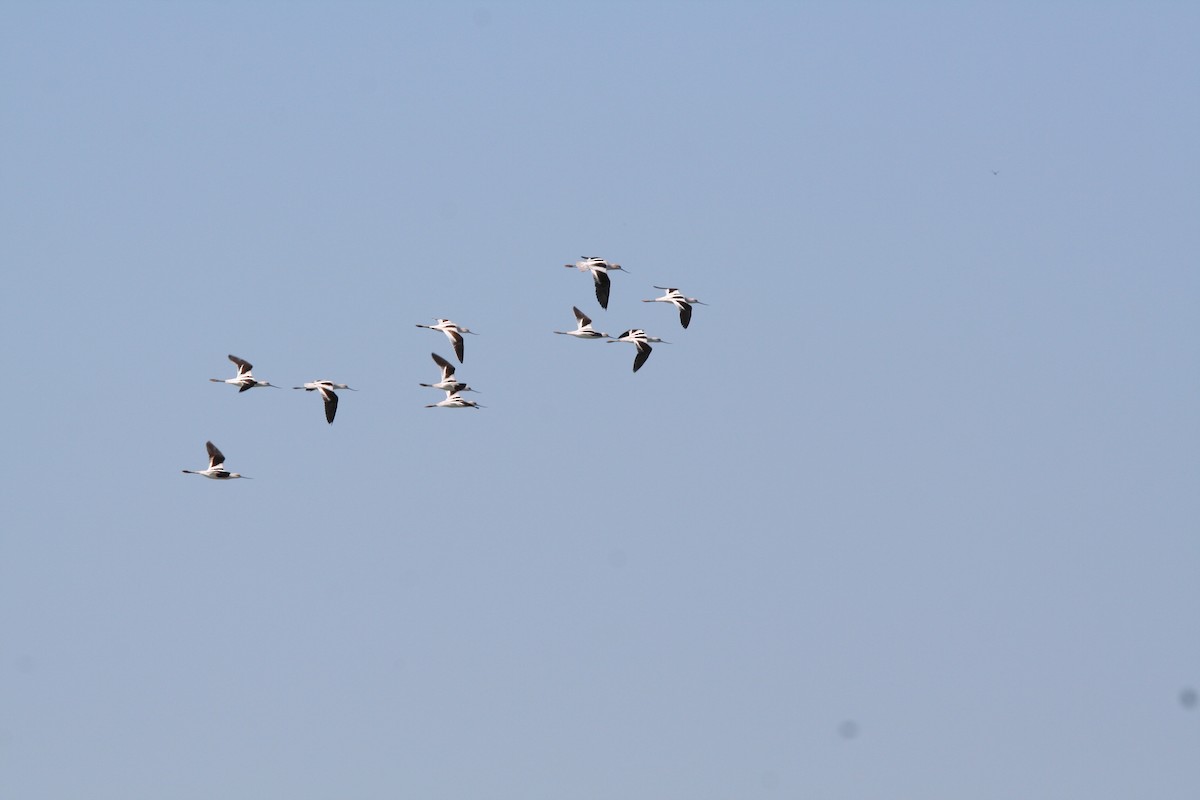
top-left (182, 255), bottom-right (707, 481)
